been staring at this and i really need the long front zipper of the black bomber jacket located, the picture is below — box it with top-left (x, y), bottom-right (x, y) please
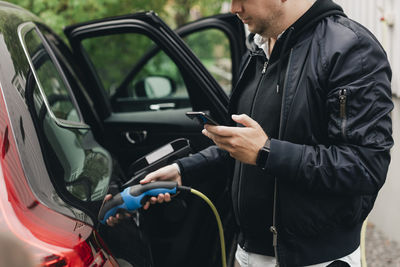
top-left (269, 48), bottom-right (293, 267)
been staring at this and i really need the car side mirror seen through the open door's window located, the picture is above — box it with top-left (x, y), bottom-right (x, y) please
top-left (134, 76), bottom-right (176, 99)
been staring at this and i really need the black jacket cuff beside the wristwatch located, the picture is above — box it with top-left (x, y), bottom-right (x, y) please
top-left (266, 139), bottom-right (304, 179)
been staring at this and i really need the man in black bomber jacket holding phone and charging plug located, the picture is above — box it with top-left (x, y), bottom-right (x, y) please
top-left (109, 0), bottom-right (393, 267)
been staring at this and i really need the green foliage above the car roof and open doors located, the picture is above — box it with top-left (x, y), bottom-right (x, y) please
top-left (8, 0), bottom-right (228, 34)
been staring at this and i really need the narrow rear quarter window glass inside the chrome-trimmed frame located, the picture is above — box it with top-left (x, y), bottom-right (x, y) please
top-left (24, 30), bottom-right (81, 122)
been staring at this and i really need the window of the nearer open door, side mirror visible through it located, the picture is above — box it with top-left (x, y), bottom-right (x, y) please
top-left (82, 33), bottom-right (190, 112)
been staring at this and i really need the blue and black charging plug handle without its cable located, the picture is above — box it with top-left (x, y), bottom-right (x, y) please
top-left (98, 182), bottom-right (178, 224)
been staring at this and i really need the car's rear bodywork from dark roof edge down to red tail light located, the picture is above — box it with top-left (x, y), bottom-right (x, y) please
top-left (0, 2), bottom-right (116, 266)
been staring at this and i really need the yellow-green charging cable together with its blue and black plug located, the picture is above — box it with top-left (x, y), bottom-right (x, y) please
top-left (98, 182), bottom-right (226, 267)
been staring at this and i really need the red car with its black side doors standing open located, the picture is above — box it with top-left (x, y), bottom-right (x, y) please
top-left (0, 2), bottom-right (245, 267)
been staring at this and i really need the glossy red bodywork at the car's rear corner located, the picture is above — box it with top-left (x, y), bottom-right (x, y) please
top-left (0, 85), bottom-right (116, 266)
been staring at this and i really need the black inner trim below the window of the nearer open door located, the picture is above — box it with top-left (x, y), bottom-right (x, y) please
top-left (105, 109), bottom-right (216, 170)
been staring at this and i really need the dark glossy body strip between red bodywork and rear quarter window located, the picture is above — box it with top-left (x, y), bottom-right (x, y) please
top-left (0, 5), bottom-right (91, 223)
